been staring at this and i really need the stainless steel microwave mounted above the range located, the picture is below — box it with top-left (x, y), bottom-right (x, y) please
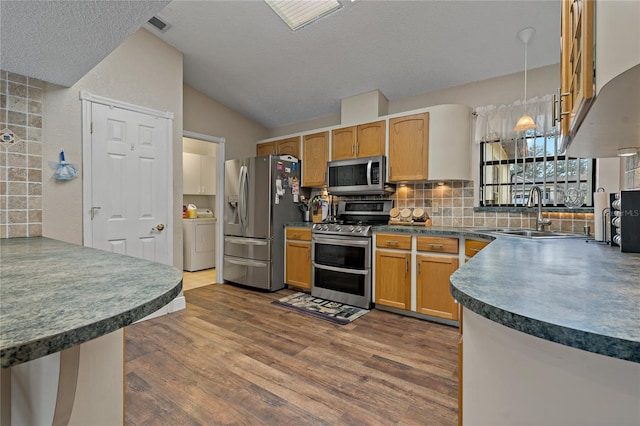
top-left (327, 156), bottom-right (395, 195)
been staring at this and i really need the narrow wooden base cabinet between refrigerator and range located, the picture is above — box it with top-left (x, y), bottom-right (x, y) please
top-left (285, 228), bottom-right (311, 289)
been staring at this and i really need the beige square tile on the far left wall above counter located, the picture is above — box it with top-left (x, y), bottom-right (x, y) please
top-left (0, 70), bottom-right (43, 238)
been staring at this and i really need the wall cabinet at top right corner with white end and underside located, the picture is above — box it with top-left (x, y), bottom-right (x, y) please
top-left (556, 0), bottom-right (640, 158)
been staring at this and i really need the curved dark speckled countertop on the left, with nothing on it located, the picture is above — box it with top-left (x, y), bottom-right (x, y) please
top-left (0, 238), bottom-right (182, 368)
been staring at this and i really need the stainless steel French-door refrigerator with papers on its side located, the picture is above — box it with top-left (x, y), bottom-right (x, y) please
top-left (223, 155), bottom-right (301, 291)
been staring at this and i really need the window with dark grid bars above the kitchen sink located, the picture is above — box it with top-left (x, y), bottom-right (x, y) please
top-left (480, 130), bottom-right (595, 207)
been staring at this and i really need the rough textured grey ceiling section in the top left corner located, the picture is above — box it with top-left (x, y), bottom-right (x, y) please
top-left (0, 0), bottom-right (169, 86)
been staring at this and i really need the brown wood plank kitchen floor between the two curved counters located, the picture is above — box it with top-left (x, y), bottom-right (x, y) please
top-left (126, 284), bottom-right (459, 425)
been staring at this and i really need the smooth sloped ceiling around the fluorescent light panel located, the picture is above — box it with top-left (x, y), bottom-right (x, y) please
top-left (151, 0), bottom-right (560, 128)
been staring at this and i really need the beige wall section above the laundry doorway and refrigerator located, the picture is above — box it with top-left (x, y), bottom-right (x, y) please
top-left (184, 84), bottom-right (269, 159)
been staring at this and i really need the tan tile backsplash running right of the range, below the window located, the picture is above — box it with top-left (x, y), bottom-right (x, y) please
top-left (391, 181), bottom-right (594, 233)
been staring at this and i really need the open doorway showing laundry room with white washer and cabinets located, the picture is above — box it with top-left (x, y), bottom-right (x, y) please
top-left (182, 131), bottom-right (225, 291)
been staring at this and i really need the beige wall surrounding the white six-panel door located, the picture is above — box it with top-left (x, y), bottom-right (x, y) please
top-left (43, 29), bottom-right (183, 267)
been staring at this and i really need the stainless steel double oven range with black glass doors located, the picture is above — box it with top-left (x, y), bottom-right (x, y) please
top-left (311, 200), bottom-right (393, 309)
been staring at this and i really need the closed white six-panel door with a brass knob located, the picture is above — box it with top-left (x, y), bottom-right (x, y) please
top-left (85, 103), bottom-right (173, 264)
